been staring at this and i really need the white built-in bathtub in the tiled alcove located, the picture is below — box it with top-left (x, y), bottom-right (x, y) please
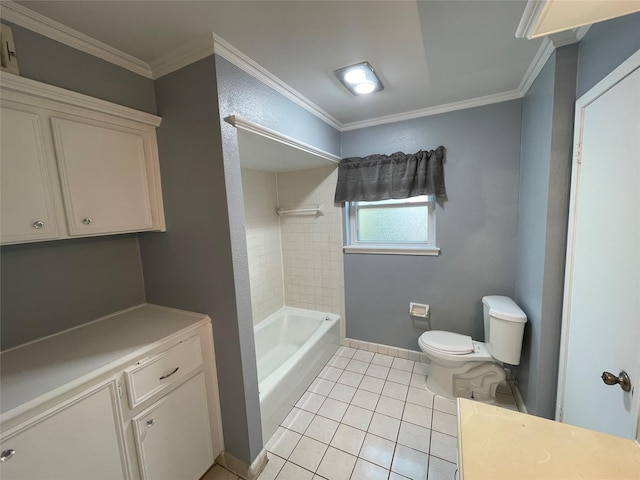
top-left (254, 307), bottom-right (340, 444)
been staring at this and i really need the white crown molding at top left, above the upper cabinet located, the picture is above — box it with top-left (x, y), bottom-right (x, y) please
top-left (2, 1), bottom-right (152, 78)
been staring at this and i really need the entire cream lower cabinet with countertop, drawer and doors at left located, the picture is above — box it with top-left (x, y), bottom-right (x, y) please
top-left (0, 305), bottom-right (223, 480)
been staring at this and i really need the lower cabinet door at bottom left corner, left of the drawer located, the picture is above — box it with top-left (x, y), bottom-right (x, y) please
top-left (0, 381), bottom-right (129, 480)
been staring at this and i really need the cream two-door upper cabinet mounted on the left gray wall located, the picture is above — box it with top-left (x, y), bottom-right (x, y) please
top-left (0, 73), bottom-right (166, 244)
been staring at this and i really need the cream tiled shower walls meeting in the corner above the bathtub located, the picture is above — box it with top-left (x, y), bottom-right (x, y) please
top-left (242, 166), bottom-right (344, 323)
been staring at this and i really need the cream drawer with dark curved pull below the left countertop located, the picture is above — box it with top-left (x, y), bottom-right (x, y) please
top-left (125, 336), bottom-right (202, 408)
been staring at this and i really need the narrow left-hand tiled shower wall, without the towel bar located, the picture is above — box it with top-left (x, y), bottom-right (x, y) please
top-left (242, 168), bottom-right (284, 324)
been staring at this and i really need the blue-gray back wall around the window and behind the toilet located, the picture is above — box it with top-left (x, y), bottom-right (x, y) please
top-left (342, 100), bottom-right (521, 350)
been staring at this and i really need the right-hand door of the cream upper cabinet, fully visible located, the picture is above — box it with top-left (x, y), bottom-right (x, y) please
top-left (51, 118), bottom-right (154, 236)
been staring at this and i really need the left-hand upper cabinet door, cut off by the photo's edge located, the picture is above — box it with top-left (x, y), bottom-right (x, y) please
top-left (0, 107), bottom-right (58, 243)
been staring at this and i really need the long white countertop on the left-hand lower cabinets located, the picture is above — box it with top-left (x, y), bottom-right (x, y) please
top-left (0, 304), bottom-right (209, 414)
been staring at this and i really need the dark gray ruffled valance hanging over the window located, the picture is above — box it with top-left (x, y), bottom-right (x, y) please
top-left (335, 146), bottom-right (447, 203)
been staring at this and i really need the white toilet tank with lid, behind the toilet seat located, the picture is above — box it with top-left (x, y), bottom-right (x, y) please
top-left (482, 295), bottom-right (527, 365)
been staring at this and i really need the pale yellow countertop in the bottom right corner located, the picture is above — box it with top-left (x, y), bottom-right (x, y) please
top-left (458, 398), bottom-right (640, 480)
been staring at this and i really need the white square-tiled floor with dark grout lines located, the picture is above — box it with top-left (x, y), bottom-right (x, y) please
top-left (203, 347), bottom-right (517, 480)
